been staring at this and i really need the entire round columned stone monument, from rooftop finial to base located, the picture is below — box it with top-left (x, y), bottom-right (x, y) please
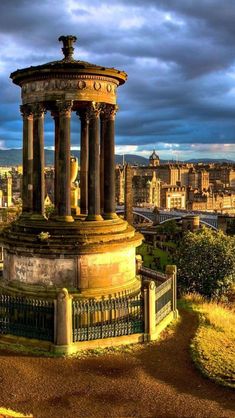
top-left (1, 36), bottom-right (142, 298)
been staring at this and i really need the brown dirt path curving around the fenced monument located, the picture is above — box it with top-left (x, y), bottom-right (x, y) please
top-left (0, 312), bottom-right (235, 418)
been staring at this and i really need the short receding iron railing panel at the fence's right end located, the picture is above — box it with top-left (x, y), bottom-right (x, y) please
top-left (155, 277), bottom-right (174, 325)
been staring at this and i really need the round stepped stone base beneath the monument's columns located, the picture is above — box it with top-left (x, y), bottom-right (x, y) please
top-left (2, 217), bottom-right (142, 298)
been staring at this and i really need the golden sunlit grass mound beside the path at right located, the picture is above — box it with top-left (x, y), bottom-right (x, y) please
top-left (185, 295), bottom-right (235, 388)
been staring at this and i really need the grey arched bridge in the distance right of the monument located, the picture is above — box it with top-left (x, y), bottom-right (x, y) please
top-left (116, 206), bottom-right (218, 230)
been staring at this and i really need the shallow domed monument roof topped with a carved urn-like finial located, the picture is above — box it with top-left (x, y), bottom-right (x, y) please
top-left (10, 35), bottom-right (127, 85)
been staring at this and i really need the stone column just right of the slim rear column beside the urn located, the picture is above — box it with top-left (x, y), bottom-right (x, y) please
top-left (86, 102), bottom-right (103, 221)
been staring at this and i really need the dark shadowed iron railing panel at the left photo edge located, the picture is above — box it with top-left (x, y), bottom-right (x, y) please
top-left (0, 294), bottom-right (54, 341)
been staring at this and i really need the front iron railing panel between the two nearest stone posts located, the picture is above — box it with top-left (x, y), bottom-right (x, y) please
top-left (72, 295), bottom-right (144, 342)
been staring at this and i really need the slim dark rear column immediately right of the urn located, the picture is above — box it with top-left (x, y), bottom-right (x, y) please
top-left (77, 110), bottom-right (89, 214)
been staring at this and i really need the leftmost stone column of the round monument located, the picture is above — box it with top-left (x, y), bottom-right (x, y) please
top-left (20, 105), bottom-right (33, 215)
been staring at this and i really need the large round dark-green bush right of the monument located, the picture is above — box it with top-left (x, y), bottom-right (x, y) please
top-left (174, 227), bottom-right (235, 299)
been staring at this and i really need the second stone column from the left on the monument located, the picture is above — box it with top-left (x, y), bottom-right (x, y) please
top-left (32, 103), bottom-right (45, 219)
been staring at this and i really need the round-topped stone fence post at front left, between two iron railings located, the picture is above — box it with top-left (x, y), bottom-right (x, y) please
top-left (55, 289), bottom-right (72, 354)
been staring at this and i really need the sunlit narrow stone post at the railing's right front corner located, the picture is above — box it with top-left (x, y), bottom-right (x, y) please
top-left (144, 280), bottom-right (156, 341)
